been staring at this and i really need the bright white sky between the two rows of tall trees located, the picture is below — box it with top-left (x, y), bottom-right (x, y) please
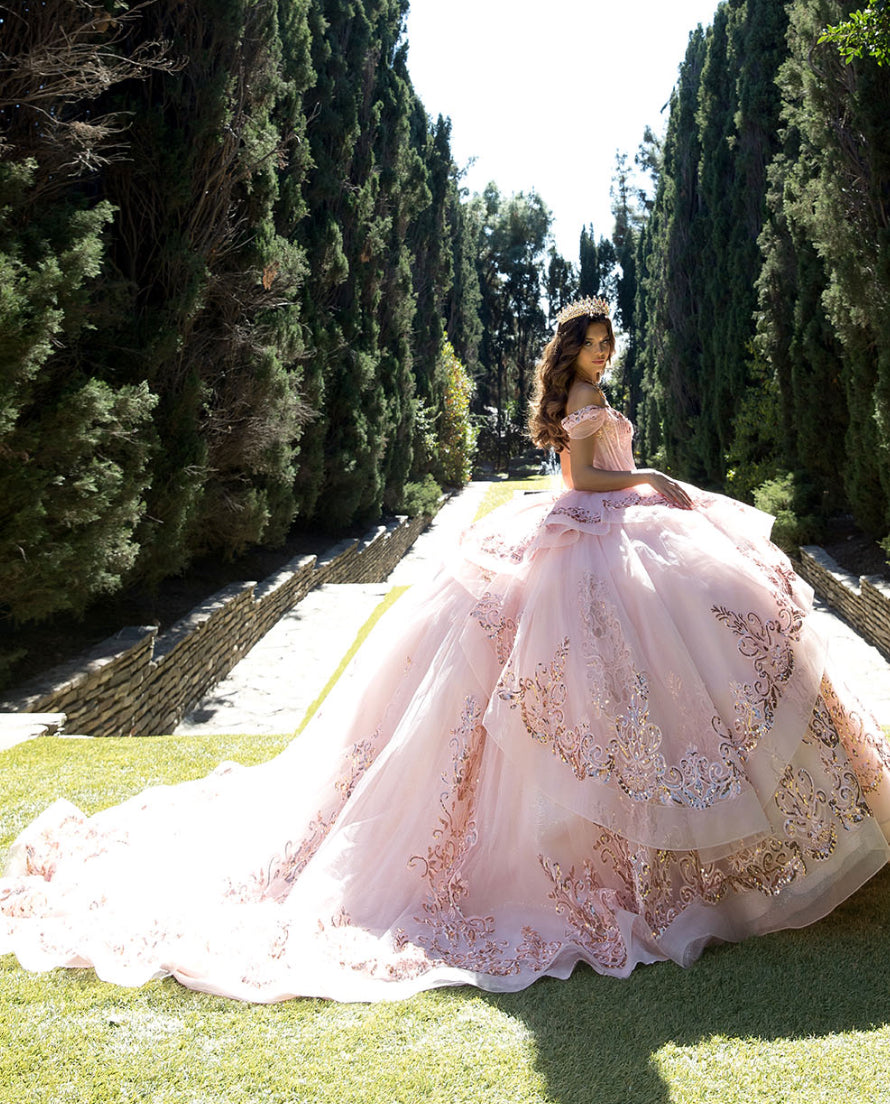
top-left (407, 0), bottom-right (718, 263)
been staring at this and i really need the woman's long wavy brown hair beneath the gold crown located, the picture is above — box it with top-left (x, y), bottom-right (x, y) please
top-left (529, 315), bottom-right (615, 453)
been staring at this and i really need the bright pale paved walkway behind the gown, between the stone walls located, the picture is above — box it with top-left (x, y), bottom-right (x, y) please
top-left (176, 482), bottom-right (890, 734)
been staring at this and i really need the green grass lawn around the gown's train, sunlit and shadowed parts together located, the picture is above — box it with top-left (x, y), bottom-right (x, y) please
top-left (0, 484), bottom-right (890, 1104)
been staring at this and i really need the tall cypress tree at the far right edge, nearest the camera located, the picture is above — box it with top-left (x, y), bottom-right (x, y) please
top-left (782, 0), bottom-right (890, 535)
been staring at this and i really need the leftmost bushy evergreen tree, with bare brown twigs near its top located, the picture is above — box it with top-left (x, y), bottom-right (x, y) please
top-left (0, 0), bottom-right (163, 644)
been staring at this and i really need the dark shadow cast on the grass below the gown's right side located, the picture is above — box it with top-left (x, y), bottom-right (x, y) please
top-left (486, 869), bottom-right (890, 1104)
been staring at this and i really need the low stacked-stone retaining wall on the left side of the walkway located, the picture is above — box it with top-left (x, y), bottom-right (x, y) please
top-left (0, 517), bottom-right (431, 736)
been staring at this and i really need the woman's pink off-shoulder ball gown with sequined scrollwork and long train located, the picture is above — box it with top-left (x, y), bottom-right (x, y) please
top-left (0, 407), bottom-right (890, 1001)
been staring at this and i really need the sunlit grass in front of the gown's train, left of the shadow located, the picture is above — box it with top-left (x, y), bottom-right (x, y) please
top-left (0, 958), bottom-right (549, 1104)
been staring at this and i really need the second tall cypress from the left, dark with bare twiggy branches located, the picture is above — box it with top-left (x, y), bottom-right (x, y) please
top-left (95, 0), bottom-right (304, 580)
